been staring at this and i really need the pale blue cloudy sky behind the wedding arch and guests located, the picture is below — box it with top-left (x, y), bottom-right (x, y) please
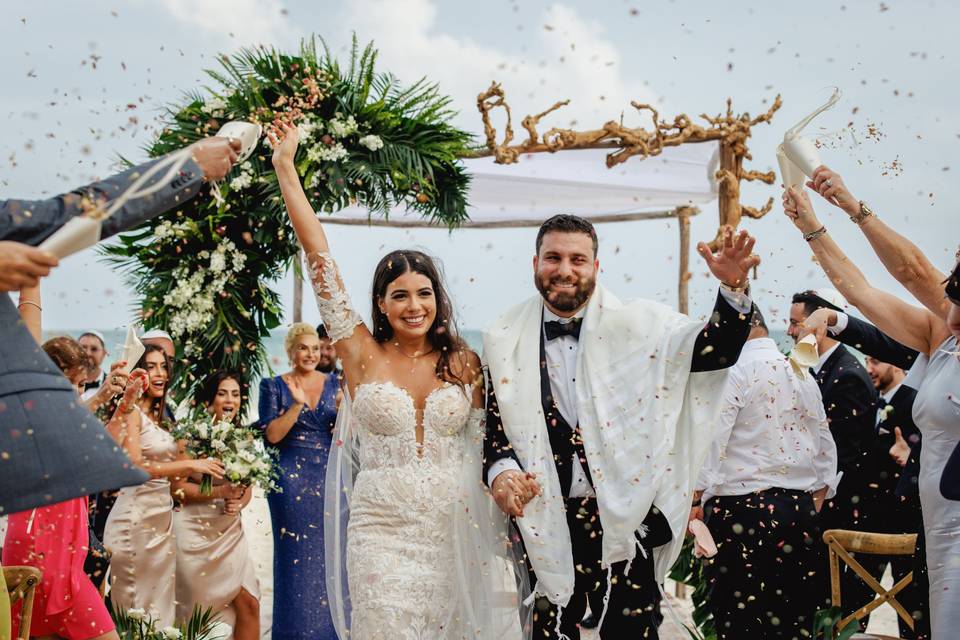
top-left (0, 0), bottom-right (960, 330)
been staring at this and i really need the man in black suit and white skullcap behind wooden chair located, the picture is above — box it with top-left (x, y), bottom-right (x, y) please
top-left (787, 289), bottom-right (877, 607)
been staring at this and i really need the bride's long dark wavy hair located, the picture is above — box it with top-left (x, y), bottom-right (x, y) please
top-left (371, 250), bottom-right (470, 385)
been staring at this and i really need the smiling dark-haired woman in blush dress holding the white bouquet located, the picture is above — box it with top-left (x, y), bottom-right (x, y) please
top-left (171, 371), bottom-right (260, 640)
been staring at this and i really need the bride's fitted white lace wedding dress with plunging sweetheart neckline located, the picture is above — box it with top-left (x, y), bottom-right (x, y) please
top-left (347, 382), bottom-right (484, 640)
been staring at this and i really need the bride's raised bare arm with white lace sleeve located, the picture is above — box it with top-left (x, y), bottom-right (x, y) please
top-left (267, 121), bottom-right (376, 385)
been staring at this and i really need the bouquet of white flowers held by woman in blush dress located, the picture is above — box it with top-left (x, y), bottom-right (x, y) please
top-left (173, 417), bottom-right (280, 496)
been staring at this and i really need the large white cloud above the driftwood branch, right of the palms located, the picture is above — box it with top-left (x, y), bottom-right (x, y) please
top-left (344, 0), bottom-right (656, 133)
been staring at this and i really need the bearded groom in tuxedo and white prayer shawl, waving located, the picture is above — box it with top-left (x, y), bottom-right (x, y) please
top-left (484, 215), bottom-right (757, 640)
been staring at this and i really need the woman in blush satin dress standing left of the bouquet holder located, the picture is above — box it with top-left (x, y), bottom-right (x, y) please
top-left (103, 344), bottom-right (223, 627)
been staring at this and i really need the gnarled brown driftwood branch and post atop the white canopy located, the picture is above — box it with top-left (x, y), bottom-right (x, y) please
top-left (474, 82), bottom-right (783, 250)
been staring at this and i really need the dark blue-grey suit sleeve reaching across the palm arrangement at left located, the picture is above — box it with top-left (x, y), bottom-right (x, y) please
top-left (0, 154), bottom-right (203, 246)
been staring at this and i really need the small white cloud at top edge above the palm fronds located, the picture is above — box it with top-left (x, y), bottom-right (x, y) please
top-left (161, 0), bottom-right (300, 47)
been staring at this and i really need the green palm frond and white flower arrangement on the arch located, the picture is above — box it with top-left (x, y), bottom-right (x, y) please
top-left (104, 39), bottom-right (471, 412)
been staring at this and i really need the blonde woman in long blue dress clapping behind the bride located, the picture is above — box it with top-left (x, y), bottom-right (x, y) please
top-left (260, 323), bottom-right (340, 640)
